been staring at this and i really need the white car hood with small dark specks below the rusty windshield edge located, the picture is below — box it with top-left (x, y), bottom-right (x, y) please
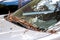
top-left (0, 15), bottom-right (60, 40)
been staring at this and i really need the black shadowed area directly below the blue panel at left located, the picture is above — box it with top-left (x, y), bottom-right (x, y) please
top-left (0, 4), bottom-right (18, 14)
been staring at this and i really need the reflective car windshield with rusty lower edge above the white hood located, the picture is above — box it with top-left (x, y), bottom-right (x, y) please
top-left (10, 0), bottom-right (57, 29)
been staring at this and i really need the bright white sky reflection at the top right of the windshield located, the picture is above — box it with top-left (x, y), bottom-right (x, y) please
top-left (37, 0), bottom-right (59, 10)
